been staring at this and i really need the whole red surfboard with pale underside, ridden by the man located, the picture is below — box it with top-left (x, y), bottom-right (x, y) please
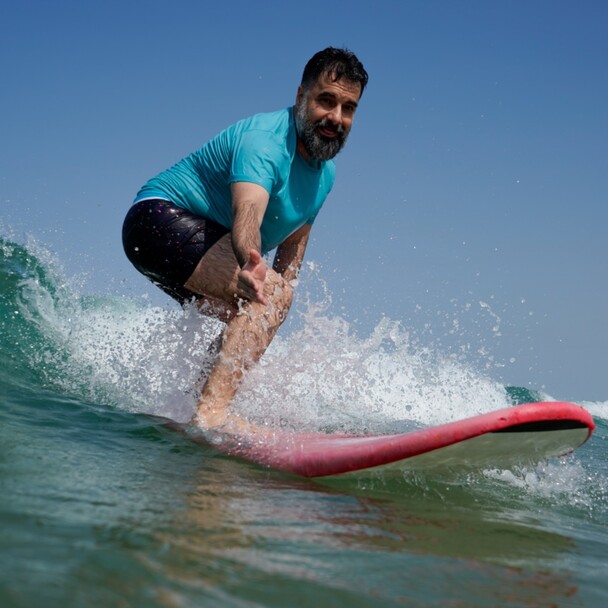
top-left (186, 402), bottom-right (595, 478)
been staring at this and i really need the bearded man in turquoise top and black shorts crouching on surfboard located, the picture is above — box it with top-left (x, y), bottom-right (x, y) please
top-left (123, 47), bottom-right (368, 431)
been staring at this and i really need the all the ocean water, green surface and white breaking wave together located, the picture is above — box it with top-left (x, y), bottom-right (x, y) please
top-left (0, 238), bottom-right (608, 608)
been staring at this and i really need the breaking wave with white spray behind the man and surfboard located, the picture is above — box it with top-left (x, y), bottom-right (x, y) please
top-left (0, 239), bottom-right (572, 432)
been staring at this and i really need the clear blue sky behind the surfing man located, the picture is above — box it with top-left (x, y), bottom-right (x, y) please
top-left (0, 0), bottom-right (608, 401)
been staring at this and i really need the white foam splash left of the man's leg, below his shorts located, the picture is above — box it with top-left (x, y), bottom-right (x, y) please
top-left (24, 285), bottom-right (226, 420)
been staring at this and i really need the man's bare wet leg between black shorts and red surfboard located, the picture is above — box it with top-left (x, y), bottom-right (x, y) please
top-left (186, 235), bottom-right (292, 428)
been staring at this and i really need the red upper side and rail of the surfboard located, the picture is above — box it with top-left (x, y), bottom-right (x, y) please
top-left (218, 401), bottom-right (595, 477)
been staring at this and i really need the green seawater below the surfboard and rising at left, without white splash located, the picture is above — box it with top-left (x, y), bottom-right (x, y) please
top-left (0, 242), bottom-right (608, 608)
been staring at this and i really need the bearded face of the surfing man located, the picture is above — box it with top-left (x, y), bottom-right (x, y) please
top-left (295, 74), bottom-right (361, 160)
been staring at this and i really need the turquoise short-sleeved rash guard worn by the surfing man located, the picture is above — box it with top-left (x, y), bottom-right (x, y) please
top-left (135, 108), bottom-right (335, 253)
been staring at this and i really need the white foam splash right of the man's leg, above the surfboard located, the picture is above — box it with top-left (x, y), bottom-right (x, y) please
top-left (237, 308), bottom-right (509, 432)
